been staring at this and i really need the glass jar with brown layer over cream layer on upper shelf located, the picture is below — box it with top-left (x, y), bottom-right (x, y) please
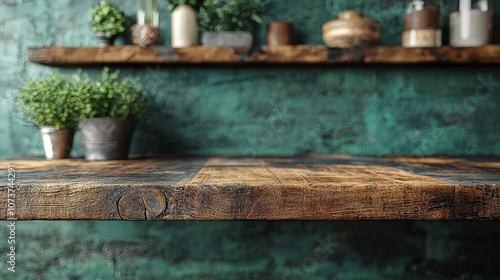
top-left (402, 0), bottom-right (441, 48)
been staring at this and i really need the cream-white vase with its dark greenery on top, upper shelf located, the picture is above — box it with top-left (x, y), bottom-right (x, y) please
top-left (169, 0), bottom-right (203, 48)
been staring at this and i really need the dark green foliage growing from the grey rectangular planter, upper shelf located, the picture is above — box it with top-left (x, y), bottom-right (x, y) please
top-left (199, 0), bottom-right (267, 31)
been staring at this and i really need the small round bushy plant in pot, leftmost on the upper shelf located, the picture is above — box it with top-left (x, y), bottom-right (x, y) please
top-left (89, 1), bottom-right (128, 46)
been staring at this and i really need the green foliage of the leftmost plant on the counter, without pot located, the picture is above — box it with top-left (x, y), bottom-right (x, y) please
top-left (16, 73), bottom-right (76, 129)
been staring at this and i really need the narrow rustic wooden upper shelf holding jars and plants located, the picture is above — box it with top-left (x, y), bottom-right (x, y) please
top-left (29, 45), bottom-right (500, 66)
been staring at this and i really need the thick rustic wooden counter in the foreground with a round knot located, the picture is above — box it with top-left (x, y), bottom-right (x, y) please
top-left (0, 155), bottom-right (500, 220)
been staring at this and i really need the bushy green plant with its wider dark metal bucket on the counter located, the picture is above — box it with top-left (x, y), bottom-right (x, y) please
top-left (75, 67), bottom-right (148, 160)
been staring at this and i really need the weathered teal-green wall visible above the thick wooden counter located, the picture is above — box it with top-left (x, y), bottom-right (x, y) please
top-left (0, 0), bottom-right (500, 158)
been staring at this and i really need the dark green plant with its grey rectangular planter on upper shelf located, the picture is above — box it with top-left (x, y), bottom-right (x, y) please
top-left (199, 0), bottom-right (267, 49)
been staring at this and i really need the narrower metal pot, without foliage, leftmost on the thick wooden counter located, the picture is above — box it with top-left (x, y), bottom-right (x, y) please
top-left (40, 126), bottom-right (75, 160)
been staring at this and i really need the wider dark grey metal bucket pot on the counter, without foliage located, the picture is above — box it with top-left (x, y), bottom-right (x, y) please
top-left (78, 118), bottom-right (135, 160)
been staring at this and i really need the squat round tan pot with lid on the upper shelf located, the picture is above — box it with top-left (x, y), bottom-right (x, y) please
top-left (323, 11), bottom-right (380, 48)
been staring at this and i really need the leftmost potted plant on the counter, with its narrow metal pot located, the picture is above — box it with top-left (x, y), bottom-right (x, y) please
top-left (16, 73), bottom-right (76, 159)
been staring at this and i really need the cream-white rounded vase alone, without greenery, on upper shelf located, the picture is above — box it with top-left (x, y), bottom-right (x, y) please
top-left (172, 4), bottom-right (199, 48)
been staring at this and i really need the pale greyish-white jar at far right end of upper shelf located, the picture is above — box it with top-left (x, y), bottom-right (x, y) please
top-left (450, 0), bottom-right (492, 47)
